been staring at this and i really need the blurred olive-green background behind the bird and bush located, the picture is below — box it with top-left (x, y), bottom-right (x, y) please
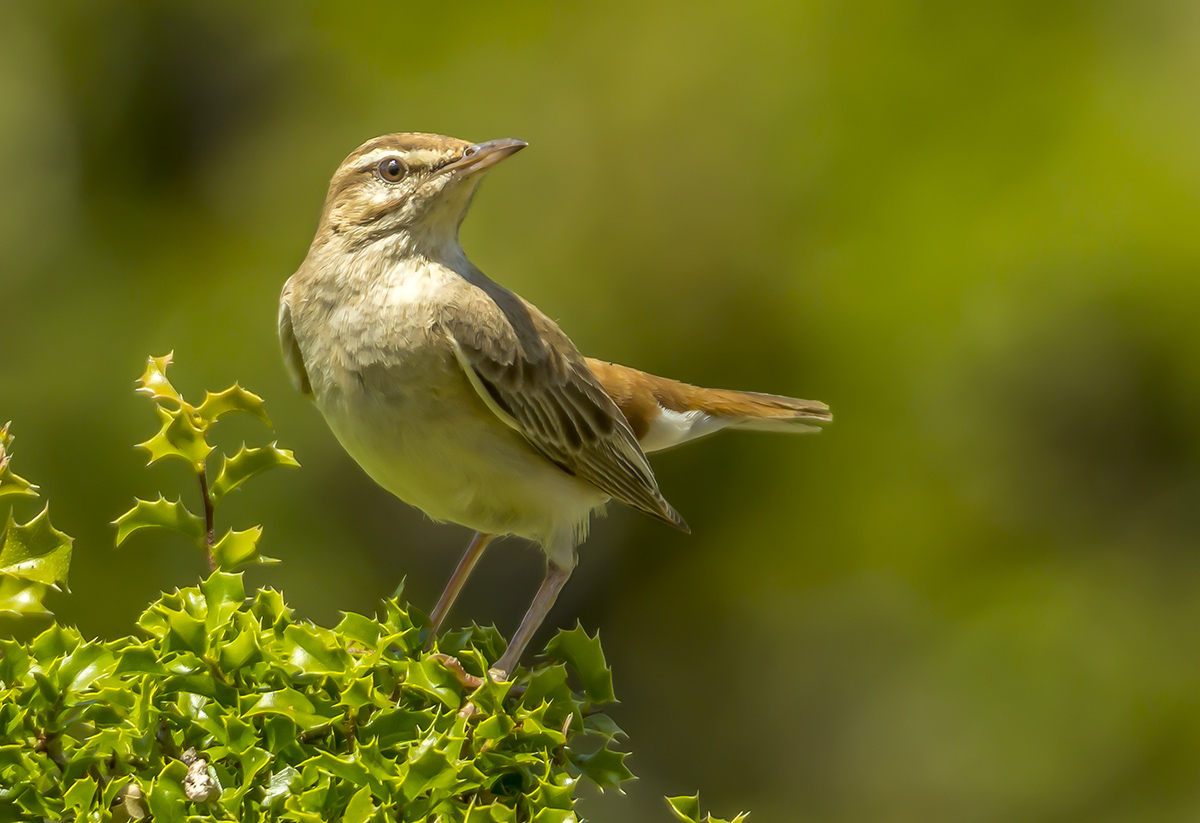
top-left (0, 0), bottom-right (1200, 823)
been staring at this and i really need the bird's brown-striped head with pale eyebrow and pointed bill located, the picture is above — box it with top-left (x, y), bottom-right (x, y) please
top-left (318, 133), bottom-right (527, 250)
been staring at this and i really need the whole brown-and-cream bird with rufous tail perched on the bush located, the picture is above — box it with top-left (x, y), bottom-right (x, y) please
top-left (278, 132), bottom-right (833, 680)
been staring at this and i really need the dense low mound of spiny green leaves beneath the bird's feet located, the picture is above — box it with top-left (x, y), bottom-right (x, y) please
top-left (0, 572), bottom-right (630, 823)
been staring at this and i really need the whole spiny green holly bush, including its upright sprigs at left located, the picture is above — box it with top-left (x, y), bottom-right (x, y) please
top-left (0, 355), bottom-right (744, 823)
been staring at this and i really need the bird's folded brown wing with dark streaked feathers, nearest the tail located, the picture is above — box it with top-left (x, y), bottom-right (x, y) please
top-left (442, 282), bottom-right (688, 531)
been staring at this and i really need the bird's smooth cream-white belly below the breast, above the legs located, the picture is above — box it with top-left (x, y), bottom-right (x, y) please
top-left (317, 352), bottom-right (607, 555)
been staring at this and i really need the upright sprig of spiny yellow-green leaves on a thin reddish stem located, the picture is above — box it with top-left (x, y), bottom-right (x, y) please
top-left (115, 354), bottom-right (299, 571)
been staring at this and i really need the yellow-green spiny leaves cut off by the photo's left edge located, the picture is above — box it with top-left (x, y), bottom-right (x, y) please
top-left (0, 423), bottom-right (72, 615)
